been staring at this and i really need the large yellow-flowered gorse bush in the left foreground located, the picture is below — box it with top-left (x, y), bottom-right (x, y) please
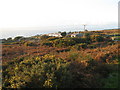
top-left (3, 55), bottom-right (72, 88)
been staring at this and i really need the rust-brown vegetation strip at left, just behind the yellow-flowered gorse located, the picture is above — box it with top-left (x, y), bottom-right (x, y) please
top-left (2, 44), bottom-right (70, 63)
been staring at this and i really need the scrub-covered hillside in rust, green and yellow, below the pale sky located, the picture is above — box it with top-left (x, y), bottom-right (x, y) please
top-left (1, 29), bottom-right (120, 88)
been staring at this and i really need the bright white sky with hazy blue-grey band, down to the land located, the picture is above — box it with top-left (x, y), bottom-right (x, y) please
top-left (0, 0), bottom-right (119, 38)
